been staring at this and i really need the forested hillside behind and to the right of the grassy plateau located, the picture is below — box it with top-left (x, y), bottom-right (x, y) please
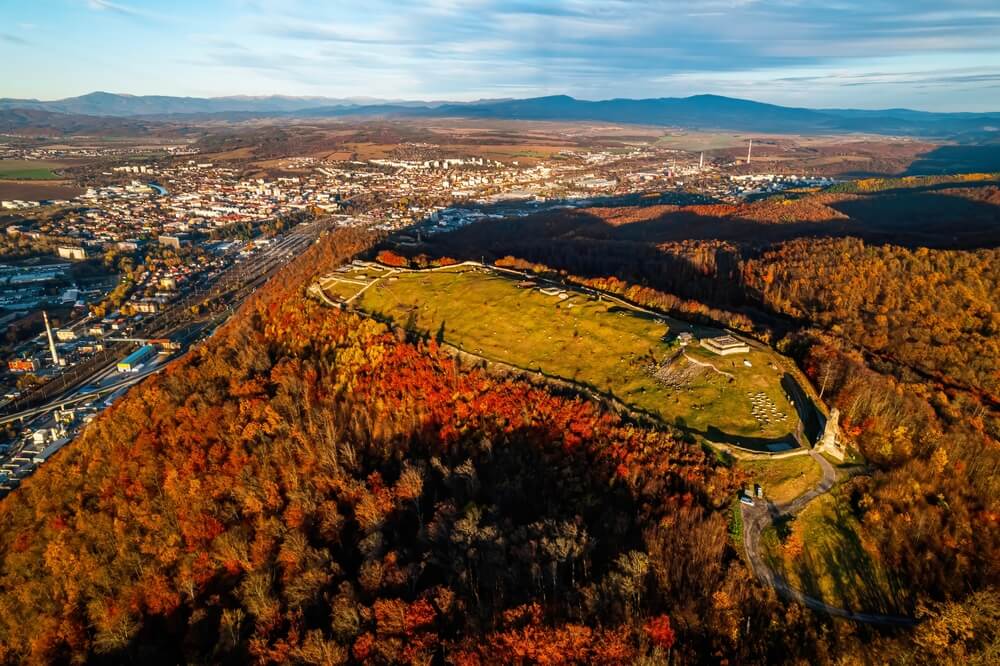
top-left (402, 179), bottom-right (1000, 663)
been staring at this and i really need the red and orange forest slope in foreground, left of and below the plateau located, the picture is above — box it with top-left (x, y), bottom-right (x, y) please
top-left (0, 231), bottom-right (826, 664)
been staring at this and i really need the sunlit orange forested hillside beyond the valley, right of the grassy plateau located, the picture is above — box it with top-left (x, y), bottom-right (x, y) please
top-left (743, 238), bottom-right (1000, 396)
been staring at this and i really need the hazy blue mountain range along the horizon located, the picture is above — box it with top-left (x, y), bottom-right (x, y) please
top-left (0, 92), bottom-right (1000, 142)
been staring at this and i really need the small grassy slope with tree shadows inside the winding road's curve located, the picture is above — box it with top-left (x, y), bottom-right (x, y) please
top-left (763, 492), bottom-right (905, 613)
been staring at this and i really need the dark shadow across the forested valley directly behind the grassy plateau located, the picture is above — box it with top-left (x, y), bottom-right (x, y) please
top-left (392, 180), bottom-right (1000, 342)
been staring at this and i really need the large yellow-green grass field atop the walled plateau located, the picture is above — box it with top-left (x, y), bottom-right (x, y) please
top-left (348, 267), bottom-right (798, 446)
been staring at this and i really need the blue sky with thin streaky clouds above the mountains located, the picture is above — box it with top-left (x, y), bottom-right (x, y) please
top-left (0, 0), bottom-right (1000, 111)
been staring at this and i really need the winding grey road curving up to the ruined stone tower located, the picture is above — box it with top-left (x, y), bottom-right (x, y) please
top-left (740, 451), bottom-right (916, 626)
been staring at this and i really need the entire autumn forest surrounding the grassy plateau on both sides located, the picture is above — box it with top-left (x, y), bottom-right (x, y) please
top-left (0, 175), bottom-right (1000, 665)
